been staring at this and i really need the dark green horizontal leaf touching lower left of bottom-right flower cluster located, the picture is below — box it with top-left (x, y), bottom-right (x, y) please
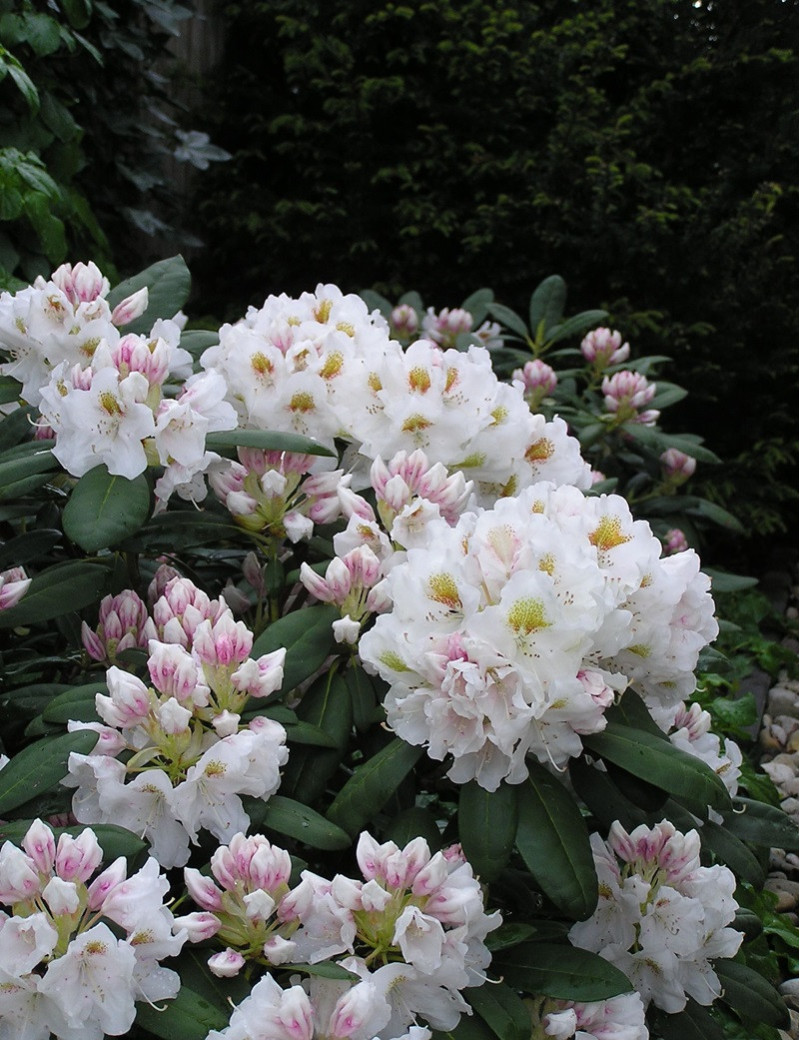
top-left (492, 942), bottom-right (633, 1000)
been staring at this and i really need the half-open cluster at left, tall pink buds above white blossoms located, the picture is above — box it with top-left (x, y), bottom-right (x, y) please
top-left (63, 578), bottom-right (288, 866)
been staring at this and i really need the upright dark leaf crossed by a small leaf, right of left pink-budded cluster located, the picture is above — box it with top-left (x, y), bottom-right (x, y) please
top-left (281, 674), bottom-right (353, 805)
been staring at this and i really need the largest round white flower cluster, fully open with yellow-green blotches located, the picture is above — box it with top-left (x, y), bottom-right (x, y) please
top-left (359, 484), bottom-right (717, 790)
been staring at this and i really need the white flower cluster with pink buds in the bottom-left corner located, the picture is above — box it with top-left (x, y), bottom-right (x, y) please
top-left (0, 820), bottom-right (186, 1040)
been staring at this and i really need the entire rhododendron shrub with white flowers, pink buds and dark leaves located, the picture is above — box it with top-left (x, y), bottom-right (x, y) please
top-left (0, 258), bottom-right (796, 1040)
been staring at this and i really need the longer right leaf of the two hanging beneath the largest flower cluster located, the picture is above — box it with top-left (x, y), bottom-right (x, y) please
top-left (517, 762), bottom-right (598, 920)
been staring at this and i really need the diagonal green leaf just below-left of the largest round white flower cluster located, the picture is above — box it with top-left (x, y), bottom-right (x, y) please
top-left (328, 737), bottom-right (422, 837)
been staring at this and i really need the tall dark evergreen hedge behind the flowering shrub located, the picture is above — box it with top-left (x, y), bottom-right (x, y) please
top-left (184, 0), bottom-right (797, 569)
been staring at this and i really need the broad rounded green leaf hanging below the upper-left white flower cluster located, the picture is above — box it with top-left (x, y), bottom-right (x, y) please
top-left (63, 466), bottom-right (150, 552)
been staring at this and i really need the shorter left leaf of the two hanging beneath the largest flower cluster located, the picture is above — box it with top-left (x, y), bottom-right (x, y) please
top-left (458, 780), bottom-right (519, 882)
